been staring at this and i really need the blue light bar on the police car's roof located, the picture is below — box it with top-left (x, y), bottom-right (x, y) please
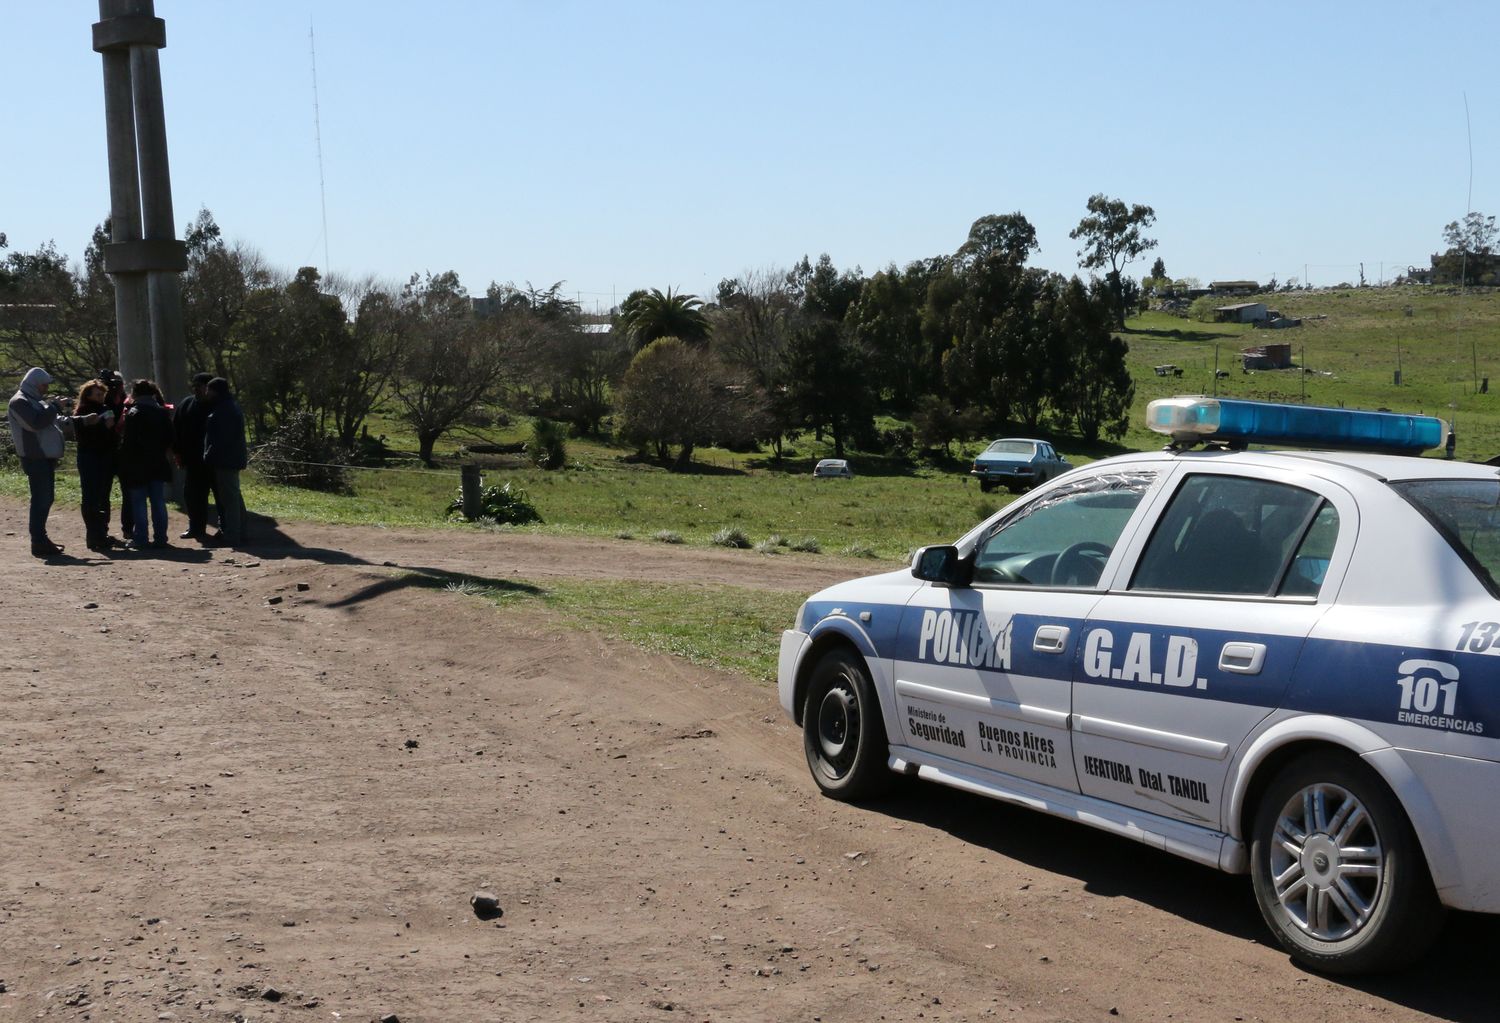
top-left (1146, 398), bottom-right (1448, 455)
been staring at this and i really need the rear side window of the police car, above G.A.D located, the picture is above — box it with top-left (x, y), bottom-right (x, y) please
top-left (1130, 474), bottom-right (1338, 597)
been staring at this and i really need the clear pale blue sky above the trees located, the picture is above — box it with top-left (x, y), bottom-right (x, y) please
top-left (0, 0), bottom-right (1500, 311)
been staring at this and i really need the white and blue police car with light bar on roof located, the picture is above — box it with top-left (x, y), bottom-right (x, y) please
top-left (779, 398), bottom-right (1500, 974)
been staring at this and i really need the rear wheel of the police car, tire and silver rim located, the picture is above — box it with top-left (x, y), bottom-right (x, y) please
top-left (1250, 752), bottom-right (1443, 974)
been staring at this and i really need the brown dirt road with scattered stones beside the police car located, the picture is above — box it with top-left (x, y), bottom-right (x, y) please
top-left (0, 501), bottom-right (1500, 1023)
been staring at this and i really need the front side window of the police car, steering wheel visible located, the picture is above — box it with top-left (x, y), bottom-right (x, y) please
top-left (974, 473), bottom-right (1155, 587)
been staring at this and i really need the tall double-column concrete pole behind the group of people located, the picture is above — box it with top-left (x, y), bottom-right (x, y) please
top-left (93, 0), bottom-right (188, 402)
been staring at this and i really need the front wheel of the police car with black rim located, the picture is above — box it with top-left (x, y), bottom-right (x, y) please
top-left (803, 650), bottom-right (894, 801)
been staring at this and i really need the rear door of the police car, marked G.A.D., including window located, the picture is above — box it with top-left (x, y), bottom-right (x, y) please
top-left (1073, 467), bottom-right (1356, 830)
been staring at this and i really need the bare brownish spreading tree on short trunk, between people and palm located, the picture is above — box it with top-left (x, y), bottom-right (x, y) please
top-left (392, 270), bottom-right (531, 465)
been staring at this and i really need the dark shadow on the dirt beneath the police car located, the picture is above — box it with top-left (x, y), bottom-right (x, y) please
top-left (872, 782), bottom-right (1500, 1023)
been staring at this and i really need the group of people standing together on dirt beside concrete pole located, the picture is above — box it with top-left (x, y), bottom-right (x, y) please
top-left (6, 366), bottom-right (249, 558)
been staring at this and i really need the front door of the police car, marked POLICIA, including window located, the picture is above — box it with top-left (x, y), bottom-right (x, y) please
top-left (894, 471), bottom-right (1157, 792)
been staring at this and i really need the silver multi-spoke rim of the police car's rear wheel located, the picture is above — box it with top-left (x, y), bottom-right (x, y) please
top-left (1271, 785), bottom-right (1385, 942)
